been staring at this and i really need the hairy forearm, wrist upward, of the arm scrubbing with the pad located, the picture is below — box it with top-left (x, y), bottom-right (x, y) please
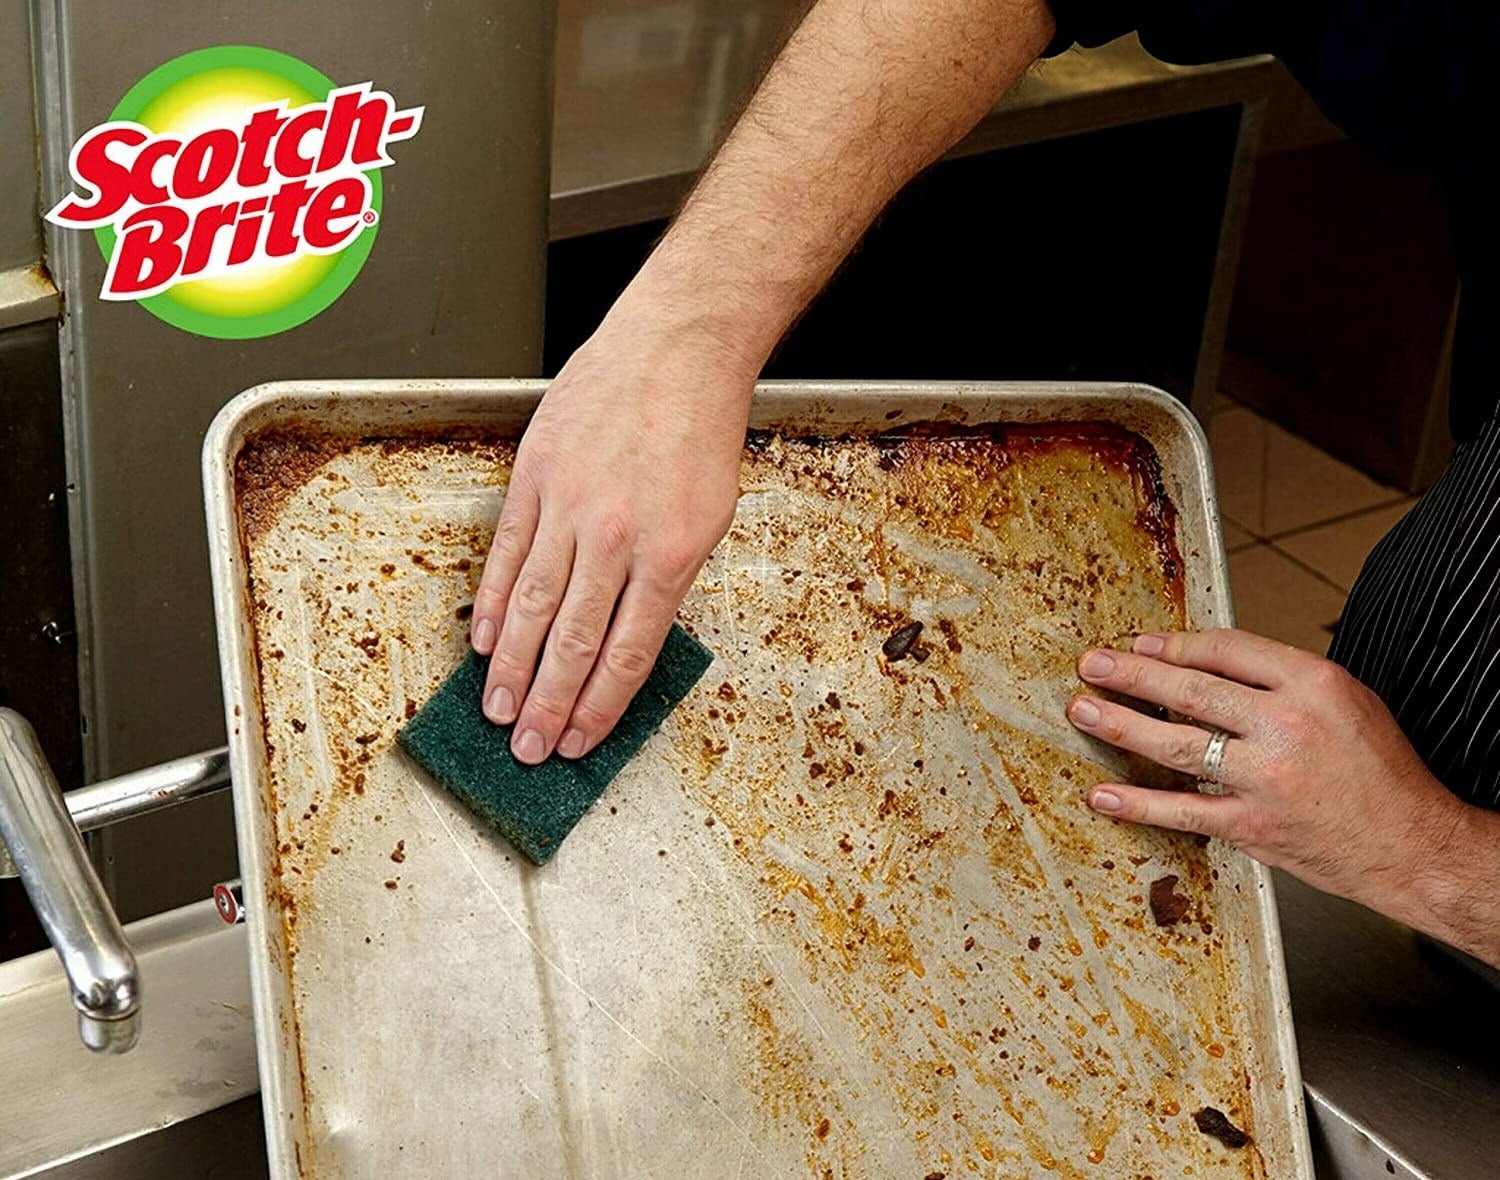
top-left (618, 0), bottom-right (1053, 372)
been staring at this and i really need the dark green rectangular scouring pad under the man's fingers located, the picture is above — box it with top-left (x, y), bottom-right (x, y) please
top-left (398, 624), bottom-right (714, 865)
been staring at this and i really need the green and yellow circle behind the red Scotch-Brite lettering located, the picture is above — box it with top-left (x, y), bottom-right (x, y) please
top-left (95, 45), bottom-right (383, 340)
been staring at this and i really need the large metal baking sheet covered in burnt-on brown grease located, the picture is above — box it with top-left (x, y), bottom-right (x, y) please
top-left (204, 382), bottom-right (1311, 1180)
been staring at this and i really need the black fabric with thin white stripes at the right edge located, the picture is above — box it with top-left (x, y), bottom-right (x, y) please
top-left (1329, 415), bottom-right (1500, 808)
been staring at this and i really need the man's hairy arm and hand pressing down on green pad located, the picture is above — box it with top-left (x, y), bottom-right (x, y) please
top-left (471, 0), bottom-right (1053, 763)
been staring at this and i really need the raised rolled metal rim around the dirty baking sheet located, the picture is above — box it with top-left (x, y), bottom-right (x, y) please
top-left (203, 379), bottom-right (1313, 1180)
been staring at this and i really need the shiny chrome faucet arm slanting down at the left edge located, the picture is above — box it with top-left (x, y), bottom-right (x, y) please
top-left (0, 708), bottom-right (141, 1053)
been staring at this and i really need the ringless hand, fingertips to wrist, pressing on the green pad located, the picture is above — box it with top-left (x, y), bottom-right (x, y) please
top-left (470, 308), bottom-right (755, 763)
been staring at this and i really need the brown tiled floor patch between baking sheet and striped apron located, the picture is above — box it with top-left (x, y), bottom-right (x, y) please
top-left (1208, 397), bottom-right (1413, 654)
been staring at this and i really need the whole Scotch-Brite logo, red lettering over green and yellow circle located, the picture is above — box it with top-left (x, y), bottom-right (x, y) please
top-left (47, 45), bottom-right (425, 340)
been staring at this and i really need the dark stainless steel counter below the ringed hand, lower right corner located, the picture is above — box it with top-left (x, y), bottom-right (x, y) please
top-left (1277, 873), bottom-right (1500, 1180)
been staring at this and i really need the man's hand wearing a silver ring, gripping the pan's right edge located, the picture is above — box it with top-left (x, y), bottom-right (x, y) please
top-left (1068, 631), bottom-right (1500, 963)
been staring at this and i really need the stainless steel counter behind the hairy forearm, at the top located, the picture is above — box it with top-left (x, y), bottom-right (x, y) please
top-left (552, 0), bottom-right (1272, 240)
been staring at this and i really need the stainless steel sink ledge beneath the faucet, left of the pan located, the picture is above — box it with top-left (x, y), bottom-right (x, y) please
top-left (0, 900), bottom-right (267, 1180)
